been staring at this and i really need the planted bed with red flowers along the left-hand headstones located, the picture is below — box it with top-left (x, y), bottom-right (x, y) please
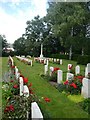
top-left (2, 56), bottom-right (51, 119)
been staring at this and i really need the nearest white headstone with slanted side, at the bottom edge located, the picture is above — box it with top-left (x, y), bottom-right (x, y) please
top-left (31, 102), bottom-right (43, 120)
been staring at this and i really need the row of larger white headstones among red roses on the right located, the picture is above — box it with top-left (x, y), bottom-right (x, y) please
top-left (44, 63), bottom-right (90, 98)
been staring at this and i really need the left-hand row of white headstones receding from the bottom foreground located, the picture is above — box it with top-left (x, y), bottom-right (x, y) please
top-left (9, 57), bottom-right (43, 120)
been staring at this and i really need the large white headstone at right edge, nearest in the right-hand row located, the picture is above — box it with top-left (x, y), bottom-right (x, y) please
top-left (81, 78), bottom-right (90, 98)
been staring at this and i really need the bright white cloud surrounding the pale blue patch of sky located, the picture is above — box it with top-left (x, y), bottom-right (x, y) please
top-left (0, 0), bottom-right (46, 43)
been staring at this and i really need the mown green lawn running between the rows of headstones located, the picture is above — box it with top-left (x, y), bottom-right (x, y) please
top-left (2, 58), bottom-right (88, 118)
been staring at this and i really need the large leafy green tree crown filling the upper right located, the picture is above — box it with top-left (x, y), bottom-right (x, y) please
top-left (46, 2), bottom-right (90, 57)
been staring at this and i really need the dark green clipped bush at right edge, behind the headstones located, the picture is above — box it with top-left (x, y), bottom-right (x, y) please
top-left (77, 55), bottom-right (90, 65)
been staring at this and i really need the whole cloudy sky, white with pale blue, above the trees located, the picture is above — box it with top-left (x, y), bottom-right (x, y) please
top-left (0, 0), bottom-right (47, 43)
